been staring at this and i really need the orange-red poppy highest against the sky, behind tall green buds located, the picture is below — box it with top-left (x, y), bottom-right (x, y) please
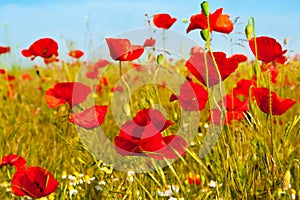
top-left (186, 8), bottom-right (233, 34)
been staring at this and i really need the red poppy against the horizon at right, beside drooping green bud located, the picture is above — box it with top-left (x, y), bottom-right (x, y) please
top-left (249, 36), bottom-right (287, 63)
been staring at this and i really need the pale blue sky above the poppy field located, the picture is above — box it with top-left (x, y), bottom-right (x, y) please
top-left (0, 0), bottom-right (300, 63)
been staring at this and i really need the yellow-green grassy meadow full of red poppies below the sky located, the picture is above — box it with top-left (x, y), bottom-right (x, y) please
top-left (0, 2), bottom-right (300, 199)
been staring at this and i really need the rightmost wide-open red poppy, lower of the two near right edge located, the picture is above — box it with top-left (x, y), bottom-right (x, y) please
top-left (253, 88), bottom-right (296, 115)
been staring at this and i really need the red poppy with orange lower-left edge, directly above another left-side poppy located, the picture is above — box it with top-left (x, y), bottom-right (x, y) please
top-left (45, 82), bottom-right (91, 108)
